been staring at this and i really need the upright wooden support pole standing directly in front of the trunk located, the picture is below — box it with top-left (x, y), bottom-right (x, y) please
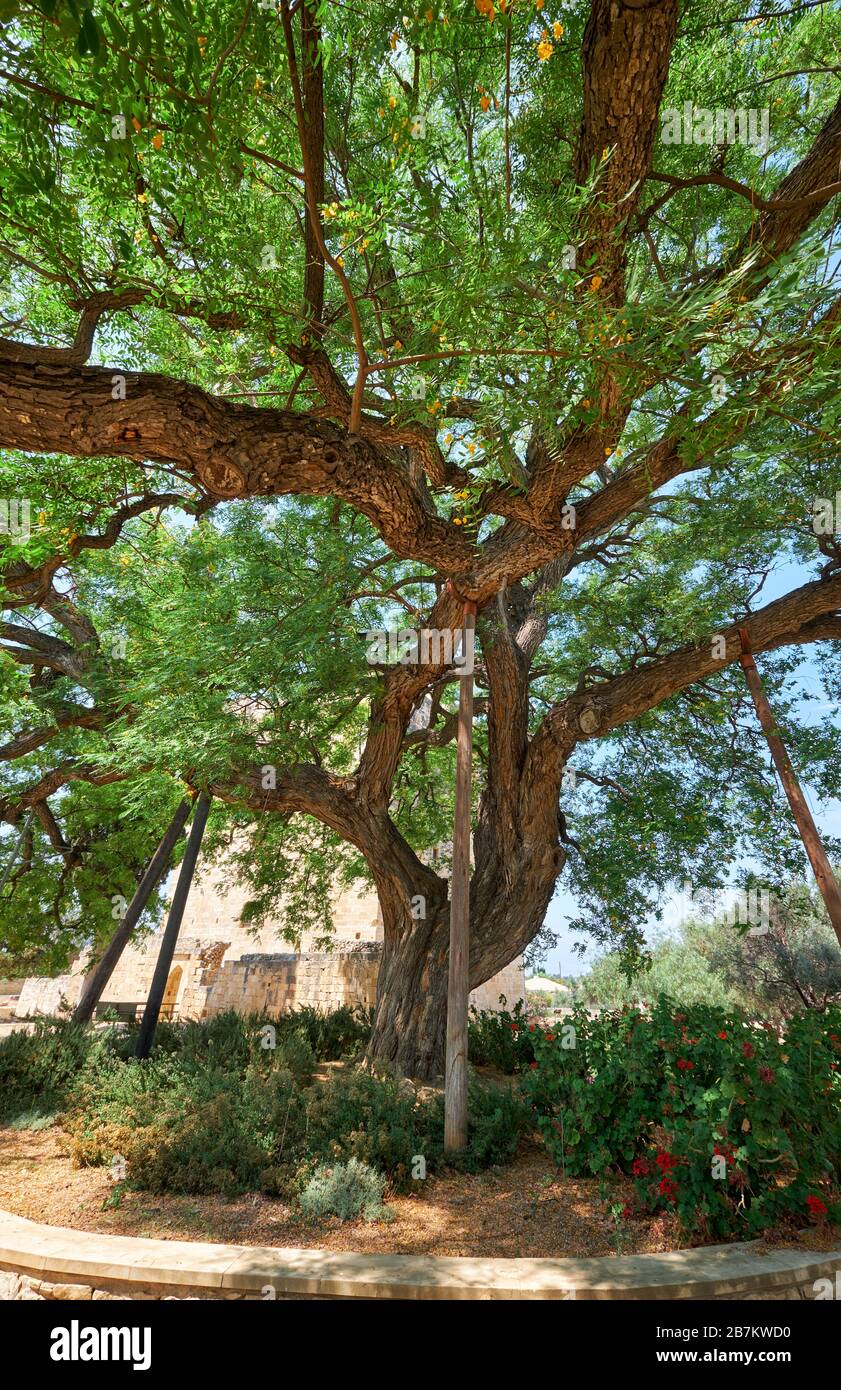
top-left (443, 602), bottom-right (475, 1154)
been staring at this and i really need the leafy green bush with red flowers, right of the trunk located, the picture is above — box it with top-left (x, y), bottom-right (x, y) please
top-left (523, 998), bottom-right (841, 1238)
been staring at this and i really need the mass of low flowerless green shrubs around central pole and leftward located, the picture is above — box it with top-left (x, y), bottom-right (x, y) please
top-left (0, 1009), bottom-right (530, 1195)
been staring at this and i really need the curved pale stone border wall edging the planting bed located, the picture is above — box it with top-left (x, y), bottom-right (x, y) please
top-left (0, 1212), bottom-right (841, 1300)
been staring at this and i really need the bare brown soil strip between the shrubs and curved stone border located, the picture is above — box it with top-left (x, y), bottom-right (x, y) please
top-left (0, 1126), bottom-right (840, 1258)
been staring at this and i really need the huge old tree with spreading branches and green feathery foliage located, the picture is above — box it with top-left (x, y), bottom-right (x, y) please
top-left (0, 0), bottom-right (841, 1076)
